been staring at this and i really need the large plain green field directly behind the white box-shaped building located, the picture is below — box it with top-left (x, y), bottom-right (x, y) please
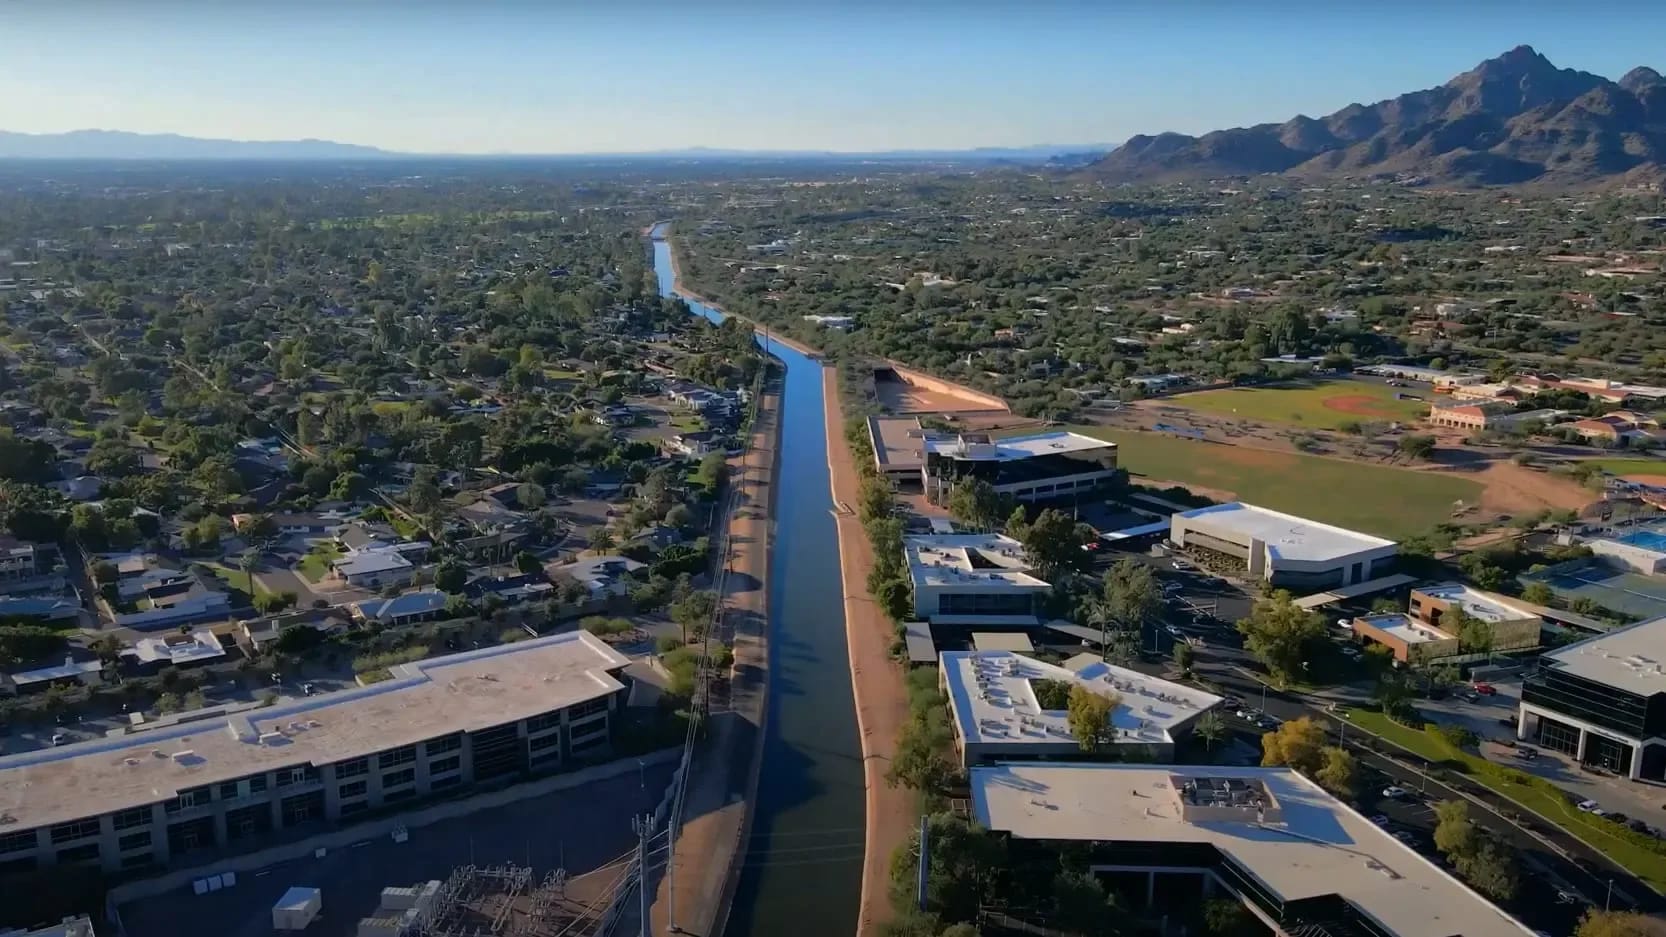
top-left (1070, 427), bottom-right (1481, 537)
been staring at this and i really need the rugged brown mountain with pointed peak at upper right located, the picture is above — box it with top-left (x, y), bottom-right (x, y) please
top-left (1088, 45), bottom-right (1666, 185)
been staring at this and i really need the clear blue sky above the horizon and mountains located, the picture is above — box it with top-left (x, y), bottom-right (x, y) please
top-left (0, 0), bottom-right (1666, 153)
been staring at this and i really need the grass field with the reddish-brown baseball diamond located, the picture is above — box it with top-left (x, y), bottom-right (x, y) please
top-left (1163, 380), bottom-right (1429, 430)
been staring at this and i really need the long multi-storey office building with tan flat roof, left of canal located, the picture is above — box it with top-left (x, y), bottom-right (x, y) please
top-left (0, 632), bottom-right (628, 874)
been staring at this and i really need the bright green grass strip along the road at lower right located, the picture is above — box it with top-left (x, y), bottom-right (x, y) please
top-left (1338, 709), bottom-right (1666, 890)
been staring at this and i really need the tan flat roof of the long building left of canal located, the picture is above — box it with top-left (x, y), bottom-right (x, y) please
top-left (0, 632), bottom-right (630, 830)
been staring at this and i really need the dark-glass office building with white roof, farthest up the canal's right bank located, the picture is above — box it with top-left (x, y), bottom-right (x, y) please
top-left (926, 432), bottom-right (1116, 504)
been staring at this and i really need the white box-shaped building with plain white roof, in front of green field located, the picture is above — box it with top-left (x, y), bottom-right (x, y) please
top-left (1170, 502), bottom-right (1399, 590)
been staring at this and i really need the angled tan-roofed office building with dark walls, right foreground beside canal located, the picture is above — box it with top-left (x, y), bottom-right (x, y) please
top-left (971, 764), bottom-right (1533, 937)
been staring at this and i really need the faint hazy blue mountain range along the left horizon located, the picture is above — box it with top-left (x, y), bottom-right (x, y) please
top-left (0, 130), bottom-right (1111, 163)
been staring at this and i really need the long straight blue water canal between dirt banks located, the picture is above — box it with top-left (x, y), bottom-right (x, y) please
top-left (653, 225), bottom-right (866, 937)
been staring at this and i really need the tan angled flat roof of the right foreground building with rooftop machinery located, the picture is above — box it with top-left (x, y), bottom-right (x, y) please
top-left (971, 762), bottom-right (1533, 937)
